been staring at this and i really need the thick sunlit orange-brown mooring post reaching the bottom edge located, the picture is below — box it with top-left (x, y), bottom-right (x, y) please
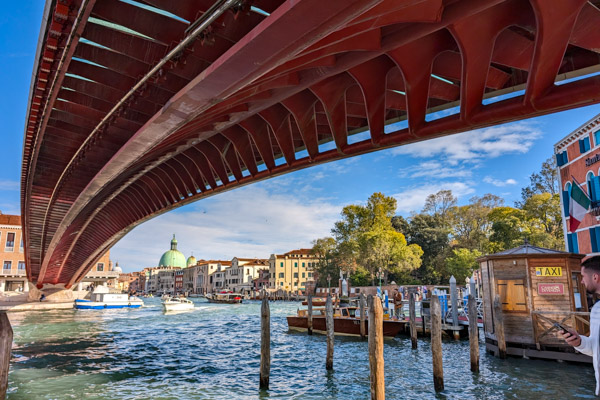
top-left (368, 295), bottom-right (385, 400)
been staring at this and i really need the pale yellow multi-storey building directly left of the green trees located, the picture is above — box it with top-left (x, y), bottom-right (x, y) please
top-left (269, 249), bottom-right (319, 293)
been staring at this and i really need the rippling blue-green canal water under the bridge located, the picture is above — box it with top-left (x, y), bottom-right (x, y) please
top-left (7, 299), bottom-right (595, 400)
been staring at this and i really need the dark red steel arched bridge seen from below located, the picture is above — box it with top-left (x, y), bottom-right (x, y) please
top-left (22, 0), bottom-right (600, 287)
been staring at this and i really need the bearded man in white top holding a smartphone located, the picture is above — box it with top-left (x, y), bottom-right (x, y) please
top-left (561, 256), bottom-right (600, 396)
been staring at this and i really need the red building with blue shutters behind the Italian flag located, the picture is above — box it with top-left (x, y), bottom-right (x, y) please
top-left (554, 115), bottom-right (600, 256)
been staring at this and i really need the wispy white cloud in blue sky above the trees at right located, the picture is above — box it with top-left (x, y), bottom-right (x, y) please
top-left (392, 122), bottom-right (542, 165)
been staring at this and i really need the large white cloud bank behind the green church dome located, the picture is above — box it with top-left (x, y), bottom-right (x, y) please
top-left (111, 183), bottom-right (342, 271)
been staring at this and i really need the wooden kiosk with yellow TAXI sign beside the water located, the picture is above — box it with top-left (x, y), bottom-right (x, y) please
top-left (477, 242), bottom-right (592, 362)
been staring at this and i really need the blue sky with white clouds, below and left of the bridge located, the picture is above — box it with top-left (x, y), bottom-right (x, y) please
top-left (0, 0), bottom-right (600, 272)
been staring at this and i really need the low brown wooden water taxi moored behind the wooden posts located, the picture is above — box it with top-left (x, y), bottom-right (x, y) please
top-left (287, 306), bottom-right (407, 338)
